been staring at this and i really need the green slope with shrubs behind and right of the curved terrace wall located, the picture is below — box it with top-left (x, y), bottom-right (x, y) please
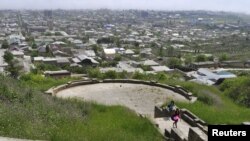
top-left (85, 70), bottom-right (250, 124)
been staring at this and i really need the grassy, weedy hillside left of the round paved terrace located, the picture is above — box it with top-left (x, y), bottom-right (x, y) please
top-left (0, 75), bottom-right (162, 141)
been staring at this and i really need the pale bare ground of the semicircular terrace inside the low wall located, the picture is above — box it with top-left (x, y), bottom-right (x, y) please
top-left (56, 83), bottom-right (188, 118)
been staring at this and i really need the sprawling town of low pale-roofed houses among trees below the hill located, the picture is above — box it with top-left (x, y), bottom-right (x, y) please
top-left (0, 9), bottom-right (250, 85)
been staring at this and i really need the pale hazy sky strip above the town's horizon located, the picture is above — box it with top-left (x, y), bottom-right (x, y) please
top-left (0, 0), bottom-right (250, 13)
